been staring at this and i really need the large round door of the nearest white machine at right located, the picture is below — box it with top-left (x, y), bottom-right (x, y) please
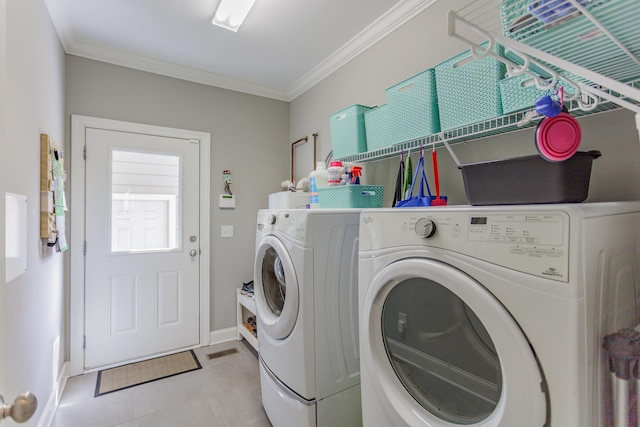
top-left (360, 258), bottom-right (552, 427)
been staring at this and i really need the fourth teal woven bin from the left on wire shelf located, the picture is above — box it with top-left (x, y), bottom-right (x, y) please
top-left (434, 42), bottom-right (506, 130)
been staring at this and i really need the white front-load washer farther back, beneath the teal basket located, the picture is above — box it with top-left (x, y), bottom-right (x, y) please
top-left (254, 209), bottom-right (362, 427)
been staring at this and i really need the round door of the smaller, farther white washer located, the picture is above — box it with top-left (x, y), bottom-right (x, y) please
top-left (254, 235), bottom-right (300, 339)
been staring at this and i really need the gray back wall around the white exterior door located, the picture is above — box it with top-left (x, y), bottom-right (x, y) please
top-left (66, 55), bottom-right (290, 331)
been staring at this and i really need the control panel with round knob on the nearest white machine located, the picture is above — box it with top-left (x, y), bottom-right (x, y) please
top-left (360, 207), bottom-right (570, 282)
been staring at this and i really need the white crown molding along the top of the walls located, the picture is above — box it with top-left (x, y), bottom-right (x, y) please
top-left (45, 0), bottom-right (436, 101)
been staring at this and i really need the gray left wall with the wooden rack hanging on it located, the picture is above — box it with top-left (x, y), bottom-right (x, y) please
top-left (0, 0), bottom-right (67, 426)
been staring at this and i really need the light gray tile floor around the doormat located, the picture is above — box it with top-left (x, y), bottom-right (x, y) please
top-left (52, 341), bottom-right (271, 427)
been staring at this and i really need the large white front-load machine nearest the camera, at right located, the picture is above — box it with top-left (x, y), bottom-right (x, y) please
top-left (359, 202), bottom-right (640, 427)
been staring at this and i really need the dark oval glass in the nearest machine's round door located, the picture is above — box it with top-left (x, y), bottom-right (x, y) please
top-left (382, 278), bottom-right (502, 425)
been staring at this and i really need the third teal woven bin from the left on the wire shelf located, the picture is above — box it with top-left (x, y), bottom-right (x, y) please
top-left (385, 68), bottom-right (440, 144)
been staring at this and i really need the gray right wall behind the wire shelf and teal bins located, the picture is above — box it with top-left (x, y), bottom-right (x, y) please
top-left (290, 0), bottom-right (640, 206)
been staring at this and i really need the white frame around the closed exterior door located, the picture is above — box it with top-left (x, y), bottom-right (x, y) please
top-left (69, 114), bottom-right (211, 376)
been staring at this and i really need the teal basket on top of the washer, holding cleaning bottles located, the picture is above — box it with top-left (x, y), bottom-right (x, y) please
top-left (318, 185), bottom-right (384, 208)
